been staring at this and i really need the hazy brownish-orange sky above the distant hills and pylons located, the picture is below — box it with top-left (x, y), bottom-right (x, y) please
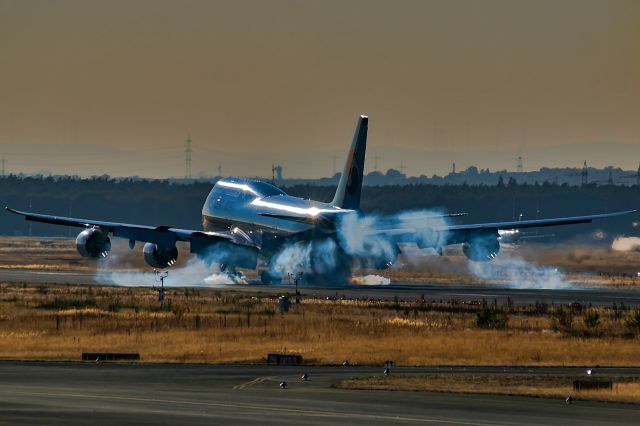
top-left (0, 0), bottom-right (640, 177)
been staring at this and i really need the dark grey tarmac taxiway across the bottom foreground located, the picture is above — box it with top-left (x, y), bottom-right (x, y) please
top-left (0, 362), bottom-right (640, 426)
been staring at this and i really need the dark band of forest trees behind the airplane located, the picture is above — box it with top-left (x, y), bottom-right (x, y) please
top-left (0, 175), bottom-right (638, 238)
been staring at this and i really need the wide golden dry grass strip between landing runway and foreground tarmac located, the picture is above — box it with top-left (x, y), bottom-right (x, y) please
top-left (0, 283), bottom-right (640, 366)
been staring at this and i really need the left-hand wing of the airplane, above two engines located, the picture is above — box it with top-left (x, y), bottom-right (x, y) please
top-left (5, 207), bottom-right (252, 251)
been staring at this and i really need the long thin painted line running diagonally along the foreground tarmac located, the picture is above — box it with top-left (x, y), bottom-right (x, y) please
top-left (0, 389), bottom-right (513, 426)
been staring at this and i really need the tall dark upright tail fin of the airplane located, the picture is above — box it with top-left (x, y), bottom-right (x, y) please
top-left (331, 115), bottom-right (369, 210)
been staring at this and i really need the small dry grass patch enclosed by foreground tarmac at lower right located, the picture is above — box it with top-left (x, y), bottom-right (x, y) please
top-left (337, 374), bottom-right (640, 403)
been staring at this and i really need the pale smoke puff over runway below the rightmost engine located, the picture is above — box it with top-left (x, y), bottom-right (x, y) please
top-left (468, 253), bottom-right (573, 289)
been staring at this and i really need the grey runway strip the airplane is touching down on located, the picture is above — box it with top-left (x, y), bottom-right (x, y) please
top-left (0, 269), bottom-right (640, 306)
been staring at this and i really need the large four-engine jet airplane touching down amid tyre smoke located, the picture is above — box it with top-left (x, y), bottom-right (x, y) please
top-left (6, 115), bottom-right (635, 284)
